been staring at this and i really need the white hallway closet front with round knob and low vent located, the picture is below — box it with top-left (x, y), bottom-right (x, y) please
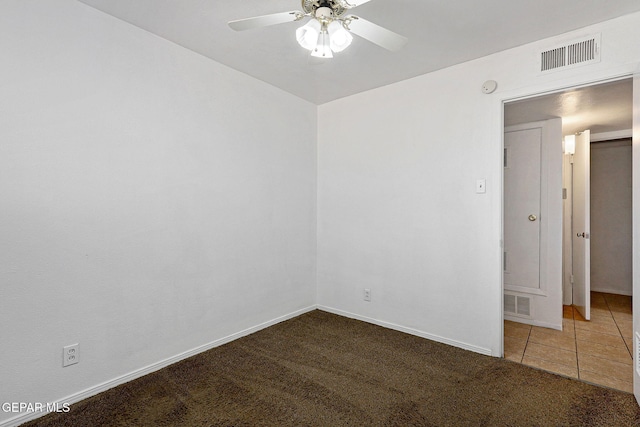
top-left (503, 119), bottom-right (562, 329)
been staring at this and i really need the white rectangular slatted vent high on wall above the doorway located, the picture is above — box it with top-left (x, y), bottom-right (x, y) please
top-left (540, 34), bottom-right (601, 73)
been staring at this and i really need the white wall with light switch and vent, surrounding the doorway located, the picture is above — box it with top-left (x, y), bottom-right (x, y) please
top-left (317, 14), bottom-right (640, 355)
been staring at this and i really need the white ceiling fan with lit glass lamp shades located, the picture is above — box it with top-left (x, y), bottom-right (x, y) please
top-left (229, 0), bottom-right (408, 58)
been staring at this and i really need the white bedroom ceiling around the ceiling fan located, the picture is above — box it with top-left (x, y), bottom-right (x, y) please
top-left (80, 0), bottom-right (640, 104)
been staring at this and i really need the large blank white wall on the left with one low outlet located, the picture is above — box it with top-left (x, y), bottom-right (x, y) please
top-left (0, 0), bottom-right (316, 423)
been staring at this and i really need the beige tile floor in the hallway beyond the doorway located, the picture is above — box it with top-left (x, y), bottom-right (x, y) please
top-left (504, 292), bottom-right (633, 393)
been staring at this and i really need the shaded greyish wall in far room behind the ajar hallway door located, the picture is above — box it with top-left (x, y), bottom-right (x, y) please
top-left (591, 140), bottom-right (633, 295)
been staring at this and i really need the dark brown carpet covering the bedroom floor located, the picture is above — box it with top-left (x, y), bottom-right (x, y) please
top-left (26, 311), bottom-right (640, 427)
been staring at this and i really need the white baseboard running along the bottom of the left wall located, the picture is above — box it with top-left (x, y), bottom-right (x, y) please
top-left (0, 305), bottom-right (317, 427)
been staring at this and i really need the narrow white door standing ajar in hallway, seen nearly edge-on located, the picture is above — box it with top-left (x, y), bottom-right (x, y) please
top-left (571, 130), bottom-right (591, 320)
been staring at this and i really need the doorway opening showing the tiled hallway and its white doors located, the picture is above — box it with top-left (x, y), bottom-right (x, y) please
top-left (503, 79), bottom-right (633, 392)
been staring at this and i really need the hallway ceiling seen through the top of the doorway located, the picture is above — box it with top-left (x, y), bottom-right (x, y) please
top-left (504, 79), bottom-right (633, 135)
